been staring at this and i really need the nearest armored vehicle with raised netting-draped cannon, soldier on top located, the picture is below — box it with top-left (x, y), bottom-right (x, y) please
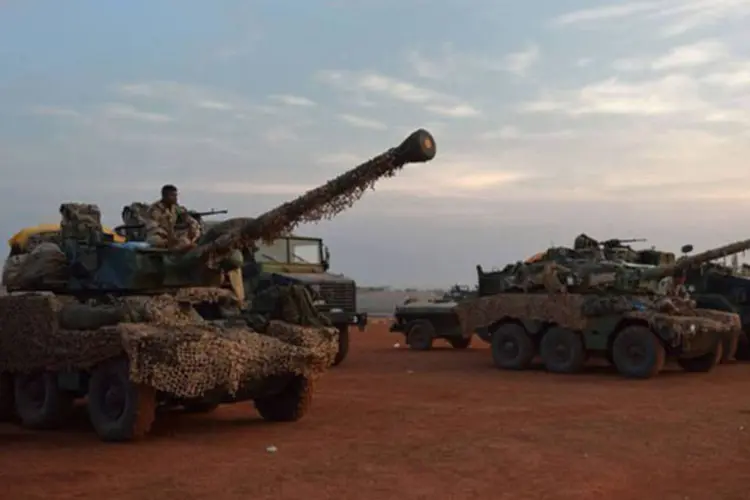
top-left (0, 130), bottom-right (435, 441)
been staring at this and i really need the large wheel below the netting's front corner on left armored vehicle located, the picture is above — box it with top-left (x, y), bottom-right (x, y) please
top-left (87, 359), bottom-right (156, 442)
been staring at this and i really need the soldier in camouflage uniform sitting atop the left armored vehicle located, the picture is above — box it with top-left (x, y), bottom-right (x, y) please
top-left (145, 184), bottom-right (201, 250)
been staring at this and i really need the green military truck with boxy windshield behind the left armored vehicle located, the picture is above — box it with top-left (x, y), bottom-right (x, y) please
top-left (243, 235), bottom-right (368, 366)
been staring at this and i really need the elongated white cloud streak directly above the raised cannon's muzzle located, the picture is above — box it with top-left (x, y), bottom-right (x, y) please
top-left (316, 70), bottom-right (481, 118)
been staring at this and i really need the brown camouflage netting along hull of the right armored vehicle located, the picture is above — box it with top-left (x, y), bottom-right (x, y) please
top-left (454, 293), bottom-right (739, 348)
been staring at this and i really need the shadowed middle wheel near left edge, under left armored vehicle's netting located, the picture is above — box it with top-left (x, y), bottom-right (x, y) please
top-left (13, 371), bottom-right (73, 429)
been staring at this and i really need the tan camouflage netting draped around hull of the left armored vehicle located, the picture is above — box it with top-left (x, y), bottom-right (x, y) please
top-left (0, 289), bottom-right (338, 398)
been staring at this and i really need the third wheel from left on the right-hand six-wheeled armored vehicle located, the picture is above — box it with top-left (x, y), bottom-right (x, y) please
top-left (612, 326), bottom-right (666, 378)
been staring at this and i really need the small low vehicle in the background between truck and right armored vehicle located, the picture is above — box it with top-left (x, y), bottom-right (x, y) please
top-left (390, 285), bottom-right (476, 351)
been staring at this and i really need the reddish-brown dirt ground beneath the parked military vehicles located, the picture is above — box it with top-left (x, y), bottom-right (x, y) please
top-left (0, 324), bottom-right (750, 500)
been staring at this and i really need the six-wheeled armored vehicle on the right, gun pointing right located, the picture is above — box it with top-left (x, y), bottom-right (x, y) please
top-left (454, 240), bottom-right (750, 378)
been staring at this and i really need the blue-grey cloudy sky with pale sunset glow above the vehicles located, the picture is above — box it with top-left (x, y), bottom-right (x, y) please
top-left (0, 0), bottom-right (750, 286)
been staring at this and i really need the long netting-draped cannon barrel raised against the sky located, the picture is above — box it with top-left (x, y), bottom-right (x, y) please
top-left (191, 129), bottom-right (436, 257)
